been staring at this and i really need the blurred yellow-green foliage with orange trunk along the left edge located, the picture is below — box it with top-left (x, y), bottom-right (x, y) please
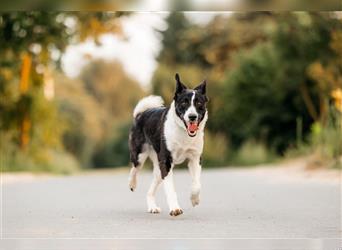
top-left (0, 11), bottom-right (134, 173)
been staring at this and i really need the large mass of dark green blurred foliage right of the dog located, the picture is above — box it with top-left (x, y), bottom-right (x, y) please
top-left (152, 12), bottom-right (342, 165)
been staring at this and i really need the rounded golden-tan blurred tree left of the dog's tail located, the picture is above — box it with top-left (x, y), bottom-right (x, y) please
top-left (56, 60), bottom-right (144, 167)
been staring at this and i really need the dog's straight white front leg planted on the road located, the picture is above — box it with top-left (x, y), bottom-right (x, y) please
top-left (164, 169), bottom-right (183, 216)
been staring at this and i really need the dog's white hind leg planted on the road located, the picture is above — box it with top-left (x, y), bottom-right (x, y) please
top-left (146, 151), bottom-right (162, 214)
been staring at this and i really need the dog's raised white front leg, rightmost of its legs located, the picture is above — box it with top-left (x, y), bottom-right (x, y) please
top-left (188, 157), bottom-right (202, 206)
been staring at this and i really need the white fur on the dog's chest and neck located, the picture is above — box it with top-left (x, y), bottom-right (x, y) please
top-left (164, 103), bottom-right (207, 164)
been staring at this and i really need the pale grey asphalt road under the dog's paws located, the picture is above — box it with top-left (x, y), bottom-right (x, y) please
top-left (2, 169), bottom-right (341, 249)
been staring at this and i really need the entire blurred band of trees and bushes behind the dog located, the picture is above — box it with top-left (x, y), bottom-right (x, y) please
top-left (0, 12), bottom-right (342, 173)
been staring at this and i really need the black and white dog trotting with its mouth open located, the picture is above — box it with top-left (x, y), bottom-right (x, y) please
top-left (129, 74), bottom-right (208, 216)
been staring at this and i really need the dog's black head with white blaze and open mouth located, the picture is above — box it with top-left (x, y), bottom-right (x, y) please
top-left (174, 74), bottom-right (208, 137)
